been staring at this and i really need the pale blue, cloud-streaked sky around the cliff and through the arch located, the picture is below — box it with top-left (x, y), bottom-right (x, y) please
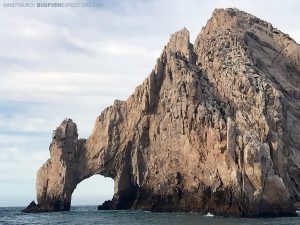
top-left (0, 0), bottom-right (300, 207)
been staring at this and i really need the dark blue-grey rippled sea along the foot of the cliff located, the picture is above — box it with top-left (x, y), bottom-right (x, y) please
top-left (0, 206), bottom-right (300, 225)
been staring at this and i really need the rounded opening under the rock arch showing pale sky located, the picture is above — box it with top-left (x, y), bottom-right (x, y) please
top-left (71, 174), bottom-right (114, 207)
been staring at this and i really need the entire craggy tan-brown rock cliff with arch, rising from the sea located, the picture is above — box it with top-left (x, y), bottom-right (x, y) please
top-left (23, 9), bottom-right (300, 217)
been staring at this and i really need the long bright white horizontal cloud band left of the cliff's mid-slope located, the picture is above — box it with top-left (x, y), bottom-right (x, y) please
top-left (0, 72), bottom-right (132, 102)
